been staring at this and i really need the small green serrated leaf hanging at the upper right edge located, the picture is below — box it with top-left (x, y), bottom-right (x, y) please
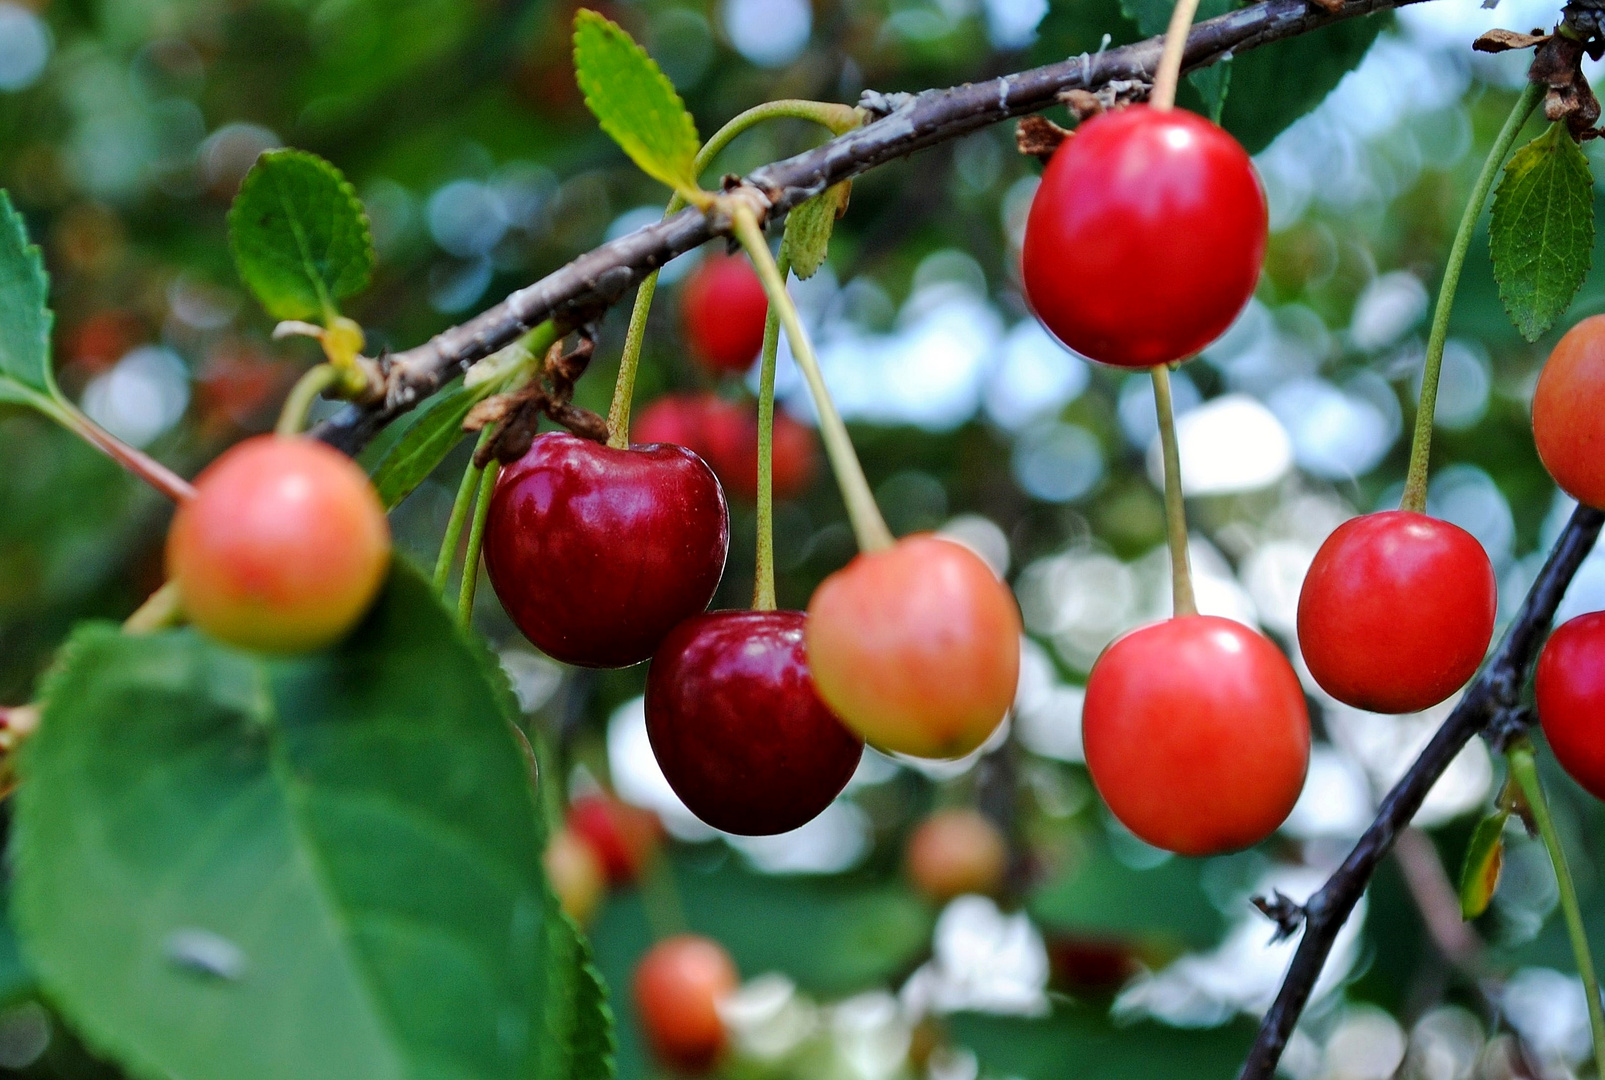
top-left (1488, 120), bottom-right (1594, 342)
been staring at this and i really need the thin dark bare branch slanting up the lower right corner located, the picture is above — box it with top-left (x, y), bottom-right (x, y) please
top-left (1237, 507), bottom-right (1605, 1080)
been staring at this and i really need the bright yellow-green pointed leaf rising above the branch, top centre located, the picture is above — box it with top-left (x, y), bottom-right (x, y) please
top-left (575, 8), bottom-right (701, 193)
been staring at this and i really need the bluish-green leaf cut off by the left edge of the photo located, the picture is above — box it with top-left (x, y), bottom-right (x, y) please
top-left (0, 189), bottom-right (61, 408)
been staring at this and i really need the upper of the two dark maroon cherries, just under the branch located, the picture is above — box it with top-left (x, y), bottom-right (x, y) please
top-left (485, 432), bottom-right (730, 668)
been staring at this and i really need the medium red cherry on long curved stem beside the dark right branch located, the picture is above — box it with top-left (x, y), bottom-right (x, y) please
top-left (1298, 510), bottom-right (1499, 713)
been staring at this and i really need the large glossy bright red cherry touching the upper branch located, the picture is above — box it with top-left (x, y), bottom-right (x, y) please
top-left (1022, 104), bottom-right (1268, 367)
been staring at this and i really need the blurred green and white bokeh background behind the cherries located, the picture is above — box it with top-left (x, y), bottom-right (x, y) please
top-left (0, 0), bottom-right (1605, 1080)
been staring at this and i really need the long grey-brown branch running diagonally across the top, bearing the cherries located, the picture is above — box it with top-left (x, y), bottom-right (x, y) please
top-left (313, 0), bottom-right (1419, 453)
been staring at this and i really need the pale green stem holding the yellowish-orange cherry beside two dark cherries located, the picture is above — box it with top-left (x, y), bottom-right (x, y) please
top-left (730, 201), bottom-right (894, 552)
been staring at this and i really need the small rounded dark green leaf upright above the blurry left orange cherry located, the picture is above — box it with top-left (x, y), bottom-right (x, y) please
top-left (228, 149), bottom-right (374, 323)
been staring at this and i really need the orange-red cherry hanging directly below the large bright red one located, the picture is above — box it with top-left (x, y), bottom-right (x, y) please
top-left (1082, 615), bottom-right (1310, 855)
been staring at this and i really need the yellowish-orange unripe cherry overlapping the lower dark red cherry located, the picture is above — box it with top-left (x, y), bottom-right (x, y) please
top-left (807, 533), bottom-right (1021, 757)
